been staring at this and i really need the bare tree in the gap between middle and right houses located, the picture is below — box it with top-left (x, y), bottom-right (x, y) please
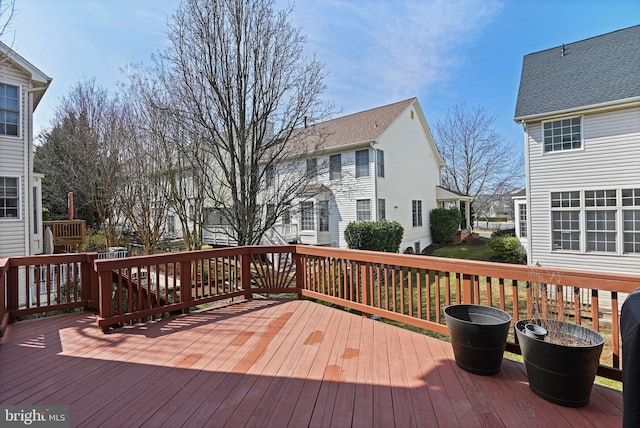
top-left (435, 104), bottom-right (524, 221)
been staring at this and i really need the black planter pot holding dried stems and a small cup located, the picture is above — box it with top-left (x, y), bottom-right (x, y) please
top-left (514, 319), bottom-right (604, 407)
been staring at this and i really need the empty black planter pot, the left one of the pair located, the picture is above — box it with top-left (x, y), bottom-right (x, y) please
top-left (444, 305), bottom-right (511, 376)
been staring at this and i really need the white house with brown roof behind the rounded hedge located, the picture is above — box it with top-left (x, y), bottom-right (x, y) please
top-left (267, 98), bottom-right (470, 253)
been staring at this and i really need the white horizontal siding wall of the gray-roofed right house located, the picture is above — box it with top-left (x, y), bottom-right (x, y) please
top-left (526, 108), bottom-right (640, 274)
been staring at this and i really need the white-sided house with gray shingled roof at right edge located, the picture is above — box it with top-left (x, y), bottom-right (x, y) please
top-left (515, 26), bottom-right (640, 274)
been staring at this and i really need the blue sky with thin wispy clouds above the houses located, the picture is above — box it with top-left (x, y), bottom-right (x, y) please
top-left (3, 0), bottom-right (640, 152)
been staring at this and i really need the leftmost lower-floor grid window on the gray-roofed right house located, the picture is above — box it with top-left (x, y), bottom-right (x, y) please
top-left (551, 192), bottom-right (580, 251)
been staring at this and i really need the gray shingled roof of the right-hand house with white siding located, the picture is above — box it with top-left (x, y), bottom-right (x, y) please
top-left (515, 25), bottom-right (640, 120)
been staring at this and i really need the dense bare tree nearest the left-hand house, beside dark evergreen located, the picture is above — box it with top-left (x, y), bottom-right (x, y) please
top-left (35, 79), bottom-right (126, 246)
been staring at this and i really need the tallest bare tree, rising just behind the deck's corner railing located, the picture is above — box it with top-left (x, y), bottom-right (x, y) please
top-left (155, 0), bottom-right (328, 245)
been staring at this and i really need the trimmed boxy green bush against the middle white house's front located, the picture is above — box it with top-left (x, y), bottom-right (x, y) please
top-left (344, 220), bottom-right (404, 253)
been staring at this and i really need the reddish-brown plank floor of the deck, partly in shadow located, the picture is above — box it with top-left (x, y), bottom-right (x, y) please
top-left (0, 300), bottom-right (622, 427)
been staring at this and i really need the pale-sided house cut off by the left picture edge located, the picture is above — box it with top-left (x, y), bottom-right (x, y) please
top-left (0, 42), bottom-right (51, 257)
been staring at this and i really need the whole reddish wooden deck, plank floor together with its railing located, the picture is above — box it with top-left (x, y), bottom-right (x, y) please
top-left (0, 246), bottom-right (639, 427)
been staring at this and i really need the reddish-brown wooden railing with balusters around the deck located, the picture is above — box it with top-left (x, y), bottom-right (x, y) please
top-left (0, 245), bottom-right (640, 380)
